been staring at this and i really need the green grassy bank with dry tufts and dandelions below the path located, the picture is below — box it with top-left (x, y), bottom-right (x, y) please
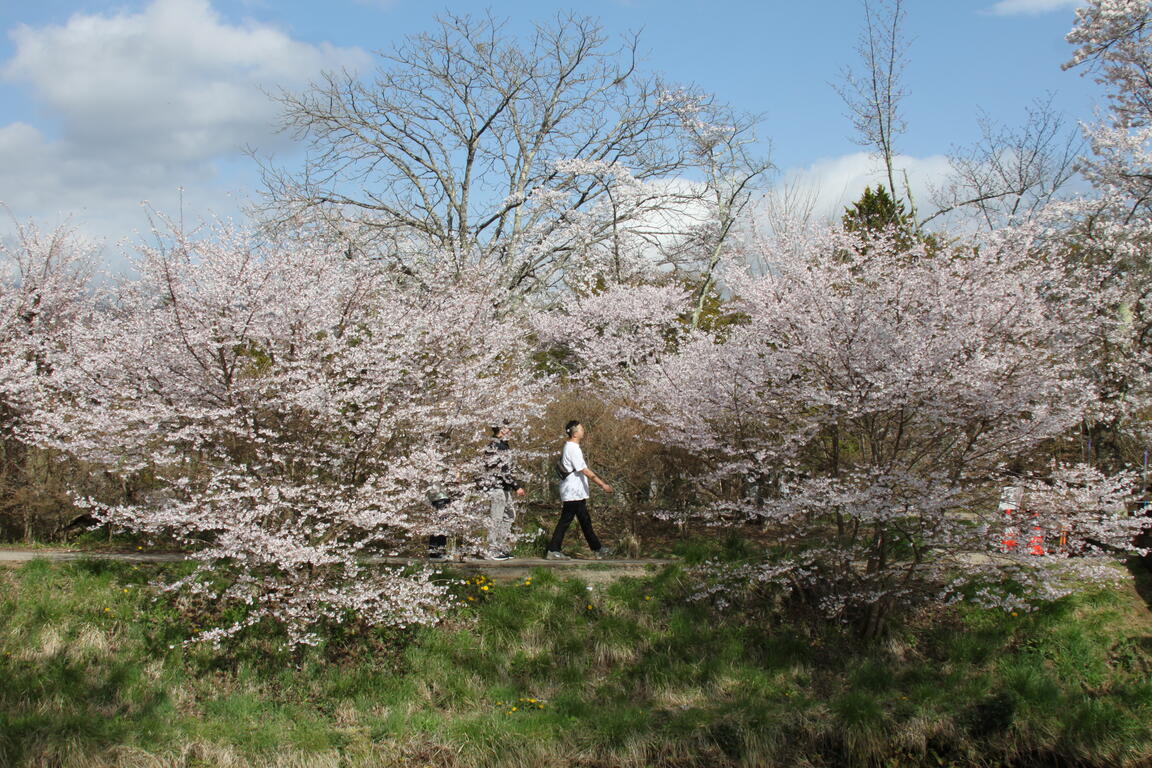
top-left (0, 562), bottom-right (1152, 768)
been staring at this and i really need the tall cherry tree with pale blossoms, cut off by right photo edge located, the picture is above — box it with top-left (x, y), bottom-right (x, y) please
top-left (1047, 0), bottom-right (1152, 464)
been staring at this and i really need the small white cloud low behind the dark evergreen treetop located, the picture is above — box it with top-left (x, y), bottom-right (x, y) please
top-left (767, 152), bottom-right (950, 227)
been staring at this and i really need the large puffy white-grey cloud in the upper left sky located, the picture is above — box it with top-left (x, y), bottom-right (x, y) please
top-left (0, 0), bottom-right (370, 246)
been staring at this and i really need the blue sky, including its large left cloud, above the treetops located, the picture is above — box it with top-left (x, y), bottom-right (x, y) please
top-left (0, 0), bottom-right (1100, 246)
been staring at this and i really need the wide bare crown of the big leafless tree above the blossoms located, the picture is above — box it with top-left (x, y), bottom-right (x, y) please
top-left (265, 14), bottom-right (764, 294)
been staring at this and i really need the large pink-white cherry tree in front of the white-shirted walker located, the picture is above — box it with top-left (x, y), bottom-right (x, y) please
top-left (544, 225), bottom-right (1139, 637)
